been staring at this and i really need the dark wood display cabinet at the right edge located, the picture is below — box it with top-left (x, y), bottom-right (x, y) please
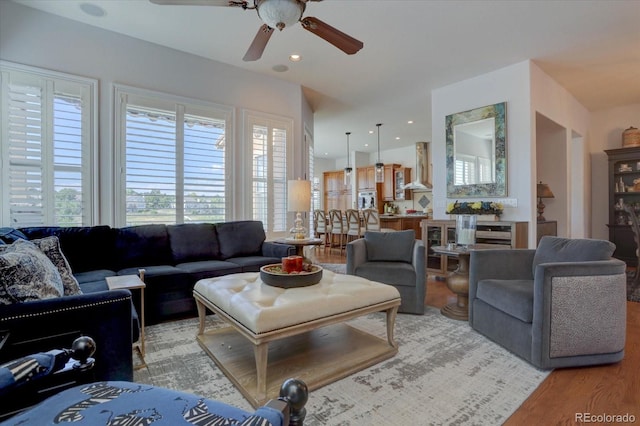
top-left (605, 147), bottom-right (640, 266)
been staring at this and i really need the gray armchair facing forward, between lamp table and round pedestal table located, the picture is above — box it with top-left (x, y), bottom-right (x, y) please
top-left (347, 230), bottom-right (427, 315)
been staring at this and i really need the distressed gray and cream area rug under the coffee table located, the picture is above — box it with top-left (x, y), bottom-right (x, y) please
top-left (135, 307), bottom-right (548, 426)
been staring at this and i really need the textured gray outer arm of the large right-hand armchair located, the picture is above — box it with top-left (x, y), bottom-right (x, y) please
top-left (532, 259), bottom-right (627, 367)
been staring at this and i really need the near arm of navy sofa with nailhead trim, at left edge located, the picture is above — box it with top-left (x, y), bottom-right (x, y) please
top-left (0, 290), bottom-right (133, 380)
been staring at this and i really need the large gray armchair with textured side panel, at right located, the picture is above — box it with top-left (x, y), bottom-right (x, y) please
top-left (469, 236), bottom-right (627, 369)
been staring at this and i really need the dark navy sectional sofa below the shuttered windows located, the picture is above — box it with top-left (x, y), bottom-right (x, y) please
top-left (0, 221), bottom-right (295, 380)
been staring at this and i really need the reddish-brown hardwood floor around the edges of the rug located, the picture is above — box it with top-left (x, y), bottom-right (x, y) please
top-left (305, 247), bottom-right (640, 426)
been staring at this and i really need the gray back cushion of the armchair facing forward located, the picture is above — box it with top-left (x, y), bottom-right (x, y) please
top-left (364, 230), bottom-right (416, 263)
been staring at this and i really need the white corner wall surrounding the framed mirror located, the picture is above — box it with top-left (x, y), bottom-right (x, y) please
top-left (431, 61), bottom-right (589, 247)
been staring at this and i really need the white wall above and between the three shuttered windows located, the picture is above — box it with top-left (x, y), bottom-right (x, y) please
top-left (0, 1), bottom-right (313, 224)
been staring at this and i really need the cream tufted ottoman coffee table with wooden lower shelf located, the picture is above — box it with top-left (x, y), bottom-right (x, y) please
top-left (193, 270), bottom-right (400, 407)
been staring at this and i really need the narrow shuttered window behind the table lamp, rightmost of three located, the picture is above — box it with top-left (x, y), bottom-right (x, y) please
top-left (245, 113), bottom-right (293, 237)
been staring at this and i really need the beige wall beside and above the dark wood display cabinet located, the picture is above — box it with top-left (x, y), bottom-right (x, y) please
top-left (589, 103), bottom-right (640, 240)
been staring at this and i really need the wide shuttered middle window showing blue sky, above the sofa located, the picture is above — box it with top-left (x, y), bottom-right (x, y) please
top-left (116, 86), bottom-right (232, 225)
